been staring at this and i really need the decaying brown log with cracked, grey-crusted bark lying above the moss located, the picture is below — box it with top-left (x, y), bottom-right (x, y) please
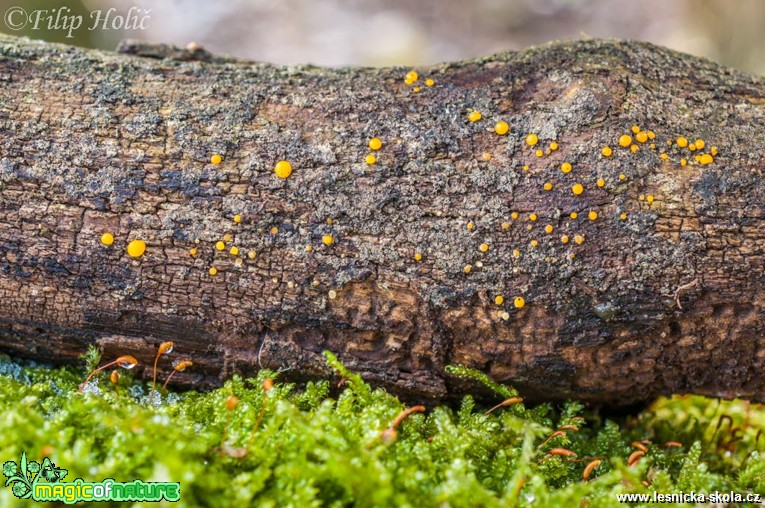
top-left (0, 36), bottom-right (765, 405)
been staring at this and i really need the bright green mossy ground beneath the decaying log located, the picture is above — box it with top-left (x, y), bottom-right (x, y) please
top-left (0, 355), bottom-right (765, 508)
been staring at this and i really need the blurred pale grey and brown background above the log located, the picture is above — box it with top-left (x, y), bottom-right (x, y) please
top-left (0, 0), bottom-right (765, 74)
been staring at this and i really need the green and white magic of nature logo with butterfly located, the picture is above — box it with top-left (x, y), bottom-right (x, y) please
top-left (3, 452), bottom-right (181, 504)
